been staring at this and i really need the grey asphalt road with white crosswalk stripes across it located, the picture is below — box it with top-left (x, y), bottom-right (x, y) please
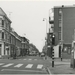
top-left (0, 56), bottom-right (51, 74)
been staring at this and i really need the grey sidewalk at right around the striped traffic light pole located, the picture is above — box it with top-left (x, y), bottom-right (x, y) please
top-left (47, 57), bottom-right (75, 75)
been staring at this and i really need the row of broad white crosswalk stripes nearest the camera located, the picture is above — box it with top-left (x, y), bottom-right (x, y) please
top-left (0, 63), bottom-right (43, 69)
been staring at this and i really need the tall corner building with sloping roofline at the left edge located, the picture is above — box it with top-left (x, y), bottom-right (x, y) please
top-left (0, 8), bottom-right (11, 57)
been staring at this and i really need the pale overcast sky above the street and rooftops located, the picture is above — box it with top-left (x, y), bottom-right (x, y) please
top-left (0, 0), bottom-right (75, 51)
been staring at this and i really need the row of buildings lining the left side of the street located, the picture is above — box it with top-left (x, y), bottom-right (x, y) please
top-left (0, 8), bottom-right (29, 57)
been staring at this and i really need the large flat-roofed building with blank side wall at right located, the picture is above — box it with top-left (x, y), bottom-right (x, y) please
top-left (51, 5), bottom-right (75, 58)
